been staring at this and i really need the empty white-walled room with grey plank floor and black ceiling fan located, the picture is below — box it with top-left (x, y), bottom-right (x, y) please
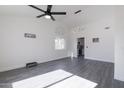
top-left (0, 5), bottom-right (124, 88)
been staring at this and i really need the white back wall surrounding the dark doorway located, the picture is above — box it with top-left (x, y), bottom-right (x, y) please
top-left (71, 17), bottom-right (114, 62)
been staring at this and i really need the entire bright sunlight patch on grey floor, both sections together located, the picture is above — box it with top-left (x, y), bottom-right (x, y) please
top-left (12, 69), bottom-right (97, 88)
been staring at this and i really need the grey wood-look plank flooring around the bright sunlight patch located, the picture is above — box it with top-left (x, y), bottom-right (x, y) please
top-left (0, 58), bottom-right (124, 88)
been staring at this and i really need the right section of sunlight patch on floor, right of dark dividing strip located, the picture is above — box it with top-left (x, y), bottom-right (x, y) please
top-left (49, 76), bottom-right (97, 88)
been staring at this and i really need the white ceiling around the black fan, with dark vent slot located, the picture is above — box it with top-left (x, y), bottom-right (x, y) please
top-left (0, 5), bottom-right (114, 27)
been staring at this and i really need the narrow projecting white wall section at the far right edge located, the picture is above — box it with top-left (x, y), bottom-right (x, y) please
top-left (114, 6), bottom-right (124, 81)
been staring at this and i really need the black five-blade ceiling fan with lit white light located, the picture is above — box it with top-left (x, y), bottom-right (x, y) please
top-left (29, 5), bottom-right (66, 21)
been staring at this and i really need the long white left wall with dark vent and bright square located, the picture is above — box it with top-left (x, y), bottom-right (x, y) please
top-left (0, 16), bottom-right (68, 71)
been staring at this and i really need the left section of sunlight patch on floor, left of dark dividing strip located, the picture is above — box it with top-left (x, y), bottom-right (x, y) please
top-left (12, 70), bottom-right (72, 88)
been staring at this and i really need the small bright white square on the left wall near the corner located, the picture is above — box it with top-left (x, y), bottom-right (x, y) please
top-left (55, 38), bottom-right (65, 50)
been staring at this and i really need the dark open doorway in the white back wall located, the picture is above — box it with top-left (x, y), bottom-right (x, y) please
top-left (77, 37), bottom-right (85, 58)
